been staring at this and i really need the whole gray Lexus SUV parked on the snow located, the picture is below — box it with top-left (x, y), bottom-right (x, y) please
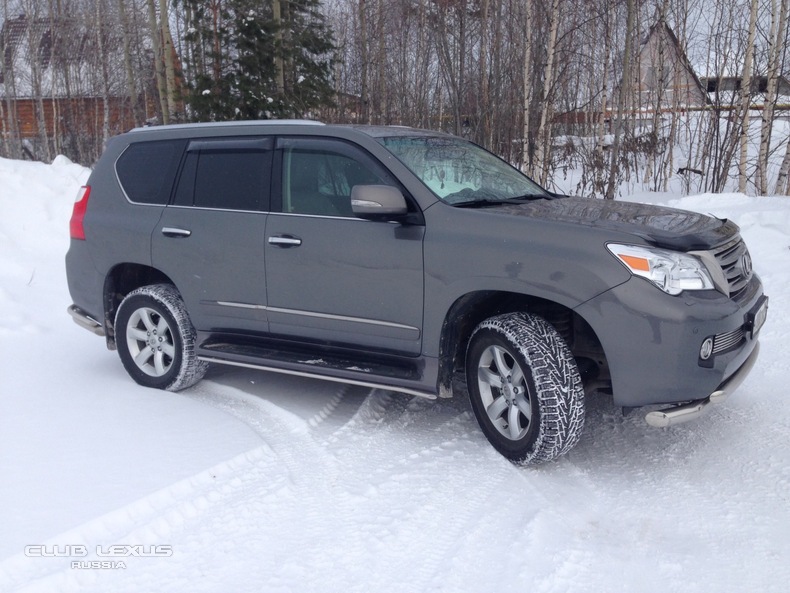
top-left (66, 121), bottom-right (767, 463)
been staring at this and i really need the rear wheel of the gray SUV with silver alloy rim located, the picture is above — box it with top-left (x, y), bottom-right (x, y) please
top-left (115, 284), bottom-right (208, 391)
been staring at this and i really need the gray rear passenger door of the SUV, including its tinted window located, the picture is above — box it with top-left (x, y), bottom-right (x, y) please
top-left (152, 137), bottom-right (273, 332)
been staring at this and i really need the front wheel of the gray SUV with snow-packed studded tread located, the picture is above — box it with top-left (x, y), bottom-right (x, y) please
top-left (466, 313), bottom-right (584, 464)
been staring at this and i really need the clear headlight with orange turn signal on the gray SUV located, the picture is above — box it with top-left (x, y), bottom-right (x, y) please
top-left (606, 243), bottom-right (714, 294)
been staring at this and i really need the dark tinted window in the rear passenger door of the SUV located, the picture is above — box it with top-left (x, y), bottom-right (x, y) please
top-left (174, 139), bottom-right (272, 211)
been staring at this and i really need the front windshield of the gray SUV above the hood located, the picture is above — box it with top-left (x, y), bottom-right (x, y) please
top-left (379, 136), bottom-right (549, 205)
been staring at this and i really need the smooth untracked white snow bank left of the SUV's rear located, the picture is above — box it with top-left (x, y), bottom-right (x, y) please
top-left (0, 157), bottom-right (266, 564)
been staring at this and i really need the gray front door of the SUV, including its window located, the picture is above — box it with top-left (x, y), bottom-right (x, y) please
top-left (265, 137), bottom-right (424, 355)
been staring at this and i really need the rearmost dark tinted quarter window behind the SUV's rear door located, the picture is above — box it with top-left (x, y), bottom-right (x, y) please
top-left (115, 140), bottom-right (186, 204)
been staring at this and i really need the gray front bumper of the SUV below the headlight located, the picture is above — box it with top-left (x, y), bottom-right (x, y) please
top-left (576, 275), bottom-right (765, 410)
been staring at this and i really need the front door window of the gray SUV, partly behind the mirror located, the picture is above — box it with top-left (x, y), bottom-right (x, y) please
top-left (282, 139), bottom-right (394, 217)
